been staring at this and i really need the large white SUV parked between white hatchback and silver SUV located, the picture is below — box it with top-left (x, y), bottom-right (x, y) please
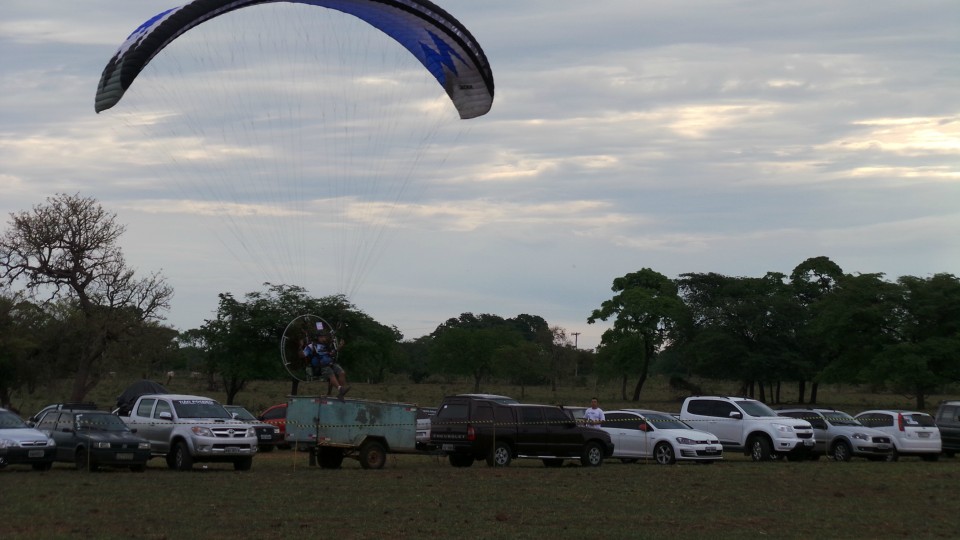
top-left (680, 396), bottom-right (816, 461)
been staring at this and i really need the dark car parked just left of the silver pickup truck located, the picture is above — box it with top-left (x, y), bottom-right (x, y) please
top-left (37, 409), bottom-right (150, 472)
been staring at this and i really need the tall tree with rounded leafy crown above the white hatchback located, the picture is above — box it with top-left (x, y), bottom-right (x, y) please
top-left (587, 268), bottom-right (686, 401)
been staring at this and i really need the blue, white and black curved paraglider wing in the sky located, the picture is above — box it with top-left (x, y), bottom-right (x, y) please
top-left (94, 0), bottom-right (493, 119)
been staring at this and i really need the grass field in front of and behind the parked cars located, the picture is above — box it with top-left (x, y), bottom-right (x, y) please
top-left (0, 380), bottom-right (960, 539)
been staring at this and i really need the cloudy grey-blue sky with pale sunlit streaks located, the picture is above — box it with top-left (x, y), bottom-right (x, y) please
top-left (0, 0), bottom-right (960, 347)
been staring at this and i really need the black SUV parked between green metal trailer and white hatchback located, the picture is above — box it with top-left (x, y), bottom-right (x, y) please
top-left (430, 395), bottom-right (613, 467)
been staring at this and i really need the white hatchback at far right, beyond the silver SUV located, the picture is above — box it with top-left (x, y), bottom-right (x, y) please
top-left (854, 410), bottom-right (942, 461)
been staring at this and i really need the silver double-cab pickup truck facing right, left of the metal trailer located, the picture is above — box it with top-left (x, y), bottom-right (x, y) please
top-left (120, 394), bottom-right (257, 471)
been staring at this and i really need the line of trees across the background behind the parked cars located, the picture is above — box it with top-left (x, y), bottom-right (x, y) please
top-left (0, 194), bottom-right (960, 408)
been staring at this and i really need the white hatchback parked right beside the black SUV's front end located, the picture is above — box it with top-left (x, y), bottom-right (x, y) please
top-left (600, 409), bottom-right (723, 465)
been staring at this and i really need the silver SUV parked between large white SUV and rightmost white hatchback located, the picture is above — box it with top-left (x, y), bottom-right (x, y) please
top-left (777, 408), bottom-right (893, 461)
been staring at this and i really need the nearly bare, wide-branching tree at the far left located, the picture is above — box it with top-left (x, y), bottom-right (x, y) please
top-left (0, 194), bottom-right (173, 401)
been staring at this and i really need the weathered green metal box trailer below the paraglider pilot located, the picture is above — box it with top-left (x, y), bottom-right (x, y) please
top-left (286, 396), bottom-right (418, 469)
